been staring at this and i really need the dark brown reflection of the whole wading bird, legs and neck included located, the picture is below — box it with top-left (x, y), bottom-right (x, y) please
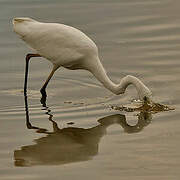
top-left (14, 95), bottom-right (151, 166)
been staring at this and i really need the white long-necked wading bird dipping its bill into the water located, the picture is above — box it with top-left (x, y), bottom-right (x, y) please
top-left (13, 17), bottom-right (152, 101)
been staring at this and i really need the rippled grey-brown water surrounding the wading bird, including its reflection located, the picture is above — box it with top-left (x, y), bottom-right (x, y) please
top-left (0, 0), bottom-right (180, 180)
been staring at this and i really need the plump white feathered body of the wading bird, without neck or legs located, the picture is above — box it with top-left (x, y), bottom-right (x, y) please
top-left (14, 19), bottom-right (98, 69)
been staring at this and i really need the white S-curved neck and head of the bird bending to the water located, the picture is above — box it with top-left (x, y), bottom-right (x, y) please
top-left (90, 58), bottom-right (150, 100)
